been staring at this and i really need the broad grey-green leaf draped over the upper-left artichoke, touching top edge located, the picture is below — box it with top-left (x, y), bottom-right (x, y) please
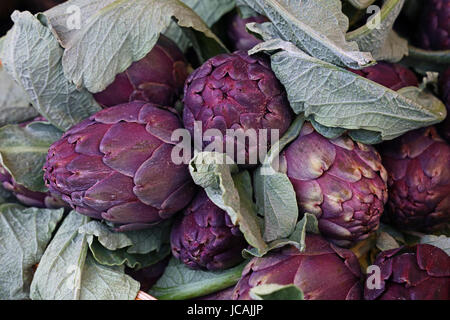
top-left (44, 0), bottom-right (226, 93)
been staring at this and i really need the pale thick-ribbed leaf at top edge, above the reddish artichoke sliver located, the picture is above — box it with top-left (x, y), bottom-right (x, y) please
top-left (346, 0), bottom-right (408, 62)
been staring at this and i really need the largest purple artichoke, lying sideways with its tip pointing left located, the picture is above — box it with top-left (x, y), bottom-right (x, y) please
top-left (44, 101), bottom-right (195, 230)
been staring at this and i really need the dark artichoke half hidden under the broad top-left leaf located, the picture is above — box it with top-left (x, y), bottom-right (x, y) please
top-left (94, 35), bottom-right (188, 108)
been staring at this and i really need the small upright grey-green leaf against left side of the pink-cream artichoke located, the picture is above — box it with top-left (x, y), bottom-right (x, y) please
top-left (253, 115), bottom-right (304, 242)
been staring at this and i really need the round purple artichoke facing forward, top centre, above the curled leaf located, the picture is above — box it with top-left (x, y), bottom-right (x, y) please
top-left (183, 51), bottom-right (293, 164)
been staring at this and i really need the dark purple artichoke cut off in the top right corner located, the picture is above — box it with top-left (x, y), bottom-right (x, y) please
top-left (418, 0), bottom-right (450, 50)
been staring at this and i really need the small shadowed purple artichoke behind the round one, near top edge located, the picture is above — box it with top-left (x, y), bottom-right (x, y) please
top-left (227, 13), bottom-right (269, 51)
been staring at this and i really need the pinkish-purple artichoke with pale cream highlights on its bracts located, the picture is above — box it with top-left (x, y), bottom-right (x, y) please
top-left (281, 123), bottom-right (388, 246)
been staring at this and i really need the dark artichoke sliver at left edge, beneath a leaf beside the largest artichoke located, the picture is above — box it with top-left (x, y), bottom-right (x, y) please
top-left (0, 166), bottom-right (68, 209)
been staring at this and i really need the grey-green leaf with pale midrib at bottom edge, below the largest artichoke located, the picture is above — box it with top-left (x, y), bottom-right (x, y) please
top-left (31, 211), bottom-right (140, 300)
